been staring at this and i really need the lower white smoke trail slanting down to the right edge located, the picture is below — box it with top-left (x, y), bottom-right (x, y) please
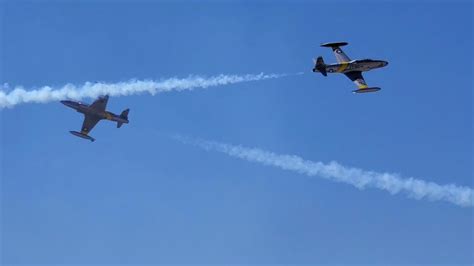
top-left (174, 136), bottom-right (474, 207)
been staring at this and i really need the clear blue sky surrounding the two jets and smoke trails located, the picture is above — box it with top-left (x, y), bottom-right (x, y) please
top-left (0, 1), bottom-right (474, 265)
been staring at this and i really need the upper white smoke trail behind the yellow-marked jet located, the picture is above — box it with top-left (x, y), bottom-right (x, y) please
top-left (0, 73), bottom-right (286, 109)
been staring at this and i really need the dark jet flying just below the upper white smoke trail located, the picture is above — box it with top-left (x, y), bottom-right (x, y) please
top-left (61, 95), bottom-right (130, 141)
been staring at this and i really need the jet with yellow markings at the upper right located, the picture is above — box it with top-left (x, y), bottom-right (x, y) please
top-left (313, 42), bottom-right (388, 93)
